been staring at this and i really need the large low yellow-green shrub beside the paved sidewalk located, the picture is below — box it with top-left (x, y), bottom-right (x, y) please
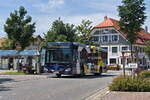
top-left (109, 76), bottom-right (150, 92)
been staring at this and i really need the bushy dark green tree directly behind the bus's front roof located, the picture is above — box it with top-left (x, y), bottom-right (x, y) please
top-left (42, 18), bottom-right (76, 45)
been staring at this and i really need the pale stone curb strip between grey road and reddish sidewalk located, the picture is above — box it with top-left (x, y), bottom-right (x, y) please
top-left (84, 87), bottom-right (110, 100)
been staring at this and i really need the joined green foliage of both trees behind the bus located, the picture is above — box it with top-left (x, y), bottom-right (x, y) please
top-left (41, 18), bottom-right (92, 46)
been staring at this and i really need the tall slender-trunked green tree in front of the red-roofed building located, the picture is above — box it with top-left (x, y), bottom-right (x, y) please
top-left (118, 0), bottom-right (146, 61)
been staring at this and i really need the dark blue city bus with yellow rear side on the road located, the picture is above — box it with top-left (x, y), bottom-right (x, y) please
top-left (41, 42), bottom-right (107, 77)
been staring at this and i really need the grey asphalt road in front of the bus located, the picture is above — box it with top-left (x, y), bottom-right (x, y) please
top-left (0, 72), bottom-right (118, 100)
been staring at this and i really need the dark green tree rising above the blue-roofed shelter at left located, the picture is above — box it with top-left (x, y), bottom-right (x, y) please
top-left (4, 6), bottom-right (35, 50)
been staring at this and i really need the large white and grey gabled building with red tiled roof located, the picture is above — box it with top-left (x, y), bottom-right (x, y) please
top-left (92, 16), bottom-right (150, 67)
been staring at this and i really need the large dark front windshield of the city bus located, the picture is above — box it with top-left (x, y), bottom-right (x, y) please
top-left (47, 48), bottom-right (72, 63)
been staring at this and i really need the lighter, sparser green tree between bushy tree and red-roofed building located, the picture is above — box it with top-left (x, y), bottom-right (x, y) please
top-left (76, 20), bottom-right (92, 44)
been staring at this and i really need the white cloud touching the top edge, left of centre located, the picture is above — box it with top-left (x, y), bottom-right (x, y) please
top-left (33, 0), bottom-right (64, 13)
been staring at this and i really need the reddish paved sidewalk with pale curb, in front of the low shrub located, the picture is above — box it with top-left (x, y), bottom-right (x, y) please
top-left (85, 88), bottom-right (150, 100)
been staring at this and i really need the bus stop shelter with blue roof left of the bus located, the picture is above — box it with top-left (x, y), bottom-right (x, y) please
top-left (0, 50), bottom-right (40, 70)
